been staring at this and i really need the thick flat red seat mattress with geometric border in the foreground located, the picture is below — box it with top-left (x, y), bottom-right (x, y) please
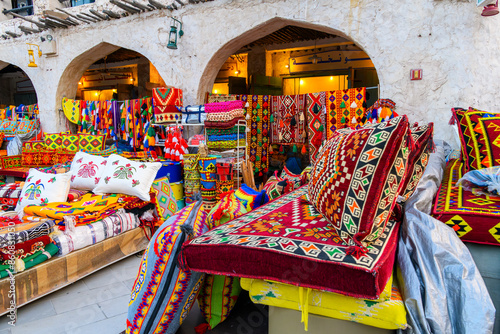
top-left (182, 185), bottom-right (399, 299)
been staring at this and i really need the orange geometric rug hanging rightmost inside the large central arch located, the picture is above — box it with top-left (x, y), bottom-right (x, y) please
top-left (326, 87), bottom-right (366, 139)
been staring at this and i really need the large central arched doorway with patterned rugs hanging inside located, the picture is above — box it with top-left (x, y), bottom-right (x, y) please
top-left (198, 18), bottom-right (379, 181)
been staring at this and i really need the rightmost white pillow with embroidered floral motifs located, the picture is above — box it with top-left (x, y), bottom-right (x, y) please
top-left (93, 154), bottom-right (162, 201)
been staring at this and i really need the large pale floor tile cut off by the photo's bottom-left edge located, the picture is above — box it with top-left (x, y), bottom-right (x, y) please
top-left (11, 305), bottom-right (106, 334)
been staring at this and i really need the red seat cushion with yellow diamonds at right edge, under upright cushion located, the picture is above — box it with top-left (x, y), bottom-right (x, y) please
top-left (432, 159), bottom-right (500, 246)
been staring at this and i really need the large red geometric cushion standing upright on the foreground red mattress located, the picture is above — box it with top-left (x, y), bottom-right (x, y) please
top-left (309, 116), bottom-right (413, 244)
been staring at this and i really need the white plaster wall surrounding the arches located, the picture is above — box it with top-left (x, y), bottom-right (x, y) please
top-left (0, 0), bottom-right (500, 147)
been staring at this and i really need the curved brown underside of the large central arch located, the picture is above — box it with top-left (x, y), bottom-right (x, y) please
top-left (196, 17), bottom-right (377, 103)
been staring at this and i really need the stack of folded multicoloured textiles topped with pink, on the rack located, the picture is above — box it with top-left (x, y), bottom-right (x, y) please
top-left (205, 100), bottom-right (246, 149)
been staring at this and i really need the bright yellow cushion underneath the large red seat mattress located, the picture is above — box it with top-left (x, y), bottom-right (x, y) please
top-left (241, 278), bottom-right (407, 329)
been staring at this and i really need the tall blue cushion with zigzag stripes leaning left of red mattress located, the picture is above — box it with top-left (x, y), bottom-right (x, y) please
top-left (127, 202), bottom-right (208, 334)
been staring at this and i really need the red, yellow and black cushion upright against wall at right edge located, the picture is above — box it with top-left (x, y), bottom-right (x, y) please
top-left (452, 108), bottom-right (500, 171)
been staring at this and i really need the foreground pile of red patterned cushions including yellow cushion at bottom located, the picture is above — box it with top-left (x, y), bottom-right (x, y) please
top-left (182, 116), bottom-right (433, 329)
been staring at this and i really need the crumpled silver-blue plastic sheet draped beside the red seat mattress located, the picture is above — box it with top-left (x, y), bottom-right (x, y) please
top-left (397, 146), bottom-right (498, 334)
